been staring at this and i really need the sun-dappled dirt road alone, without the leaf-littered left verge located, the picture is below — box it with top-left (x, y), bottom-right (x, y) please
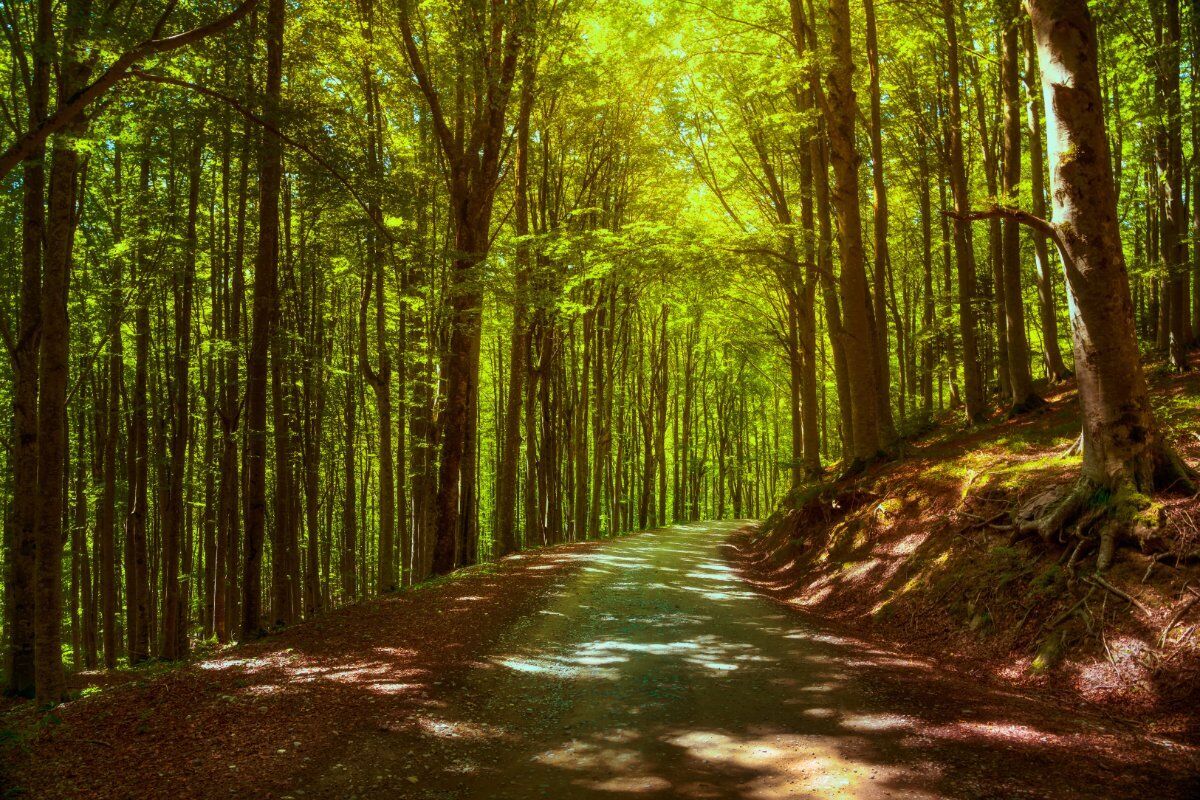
top-left (302, 523), bottom-right (1200, 800)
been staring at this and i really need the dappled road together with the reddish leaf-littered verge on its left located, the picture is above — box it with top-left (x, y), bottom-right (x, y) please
top-left (2, 523), bottom-right (1200, 800)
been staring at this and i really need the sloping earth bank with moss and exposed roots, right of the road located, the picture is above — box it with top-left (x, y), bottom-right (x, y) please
top-left (737, 365), bottom-right (1200, 742)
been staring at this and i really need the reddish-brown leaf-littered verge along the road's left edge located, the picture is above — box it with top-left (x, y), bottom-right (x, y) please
top-left (0, 543), bottom-right (595, 800)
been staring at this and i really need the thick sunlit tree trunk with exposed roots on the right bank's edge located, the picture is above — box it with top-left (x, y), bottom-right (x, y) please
top-left (1027, 0), bottom-right (1192, 569)
